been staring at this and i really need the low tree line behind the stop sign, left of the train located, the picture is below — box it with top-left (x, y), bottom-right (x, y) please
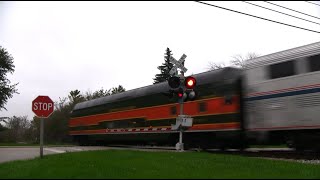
top-left (0, 85), bottom-right (125, 144)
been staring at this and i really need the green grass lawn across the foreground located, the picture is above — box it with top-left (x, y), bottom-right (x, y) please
top-left (0, 150), bottom-right (320, 179)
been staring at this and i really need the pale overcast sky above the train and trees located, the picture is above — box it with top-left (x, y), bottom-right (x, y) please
top-left (0, 1), bottom-right (320, 119)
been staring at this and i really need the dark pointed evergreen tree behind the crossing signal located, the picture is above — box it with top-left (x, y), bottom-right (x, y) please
top-left (153, 48), bottom-right (173, 84)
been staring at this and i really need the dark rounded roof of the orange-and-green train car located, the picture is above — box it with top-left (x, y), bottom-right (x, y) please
top-left (73, 67), bottom-right (242, 111)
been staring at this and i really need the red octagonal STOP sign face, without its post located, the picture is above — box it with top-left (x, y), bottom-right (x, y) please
top-left (32, 96), bottom-right (54, 118)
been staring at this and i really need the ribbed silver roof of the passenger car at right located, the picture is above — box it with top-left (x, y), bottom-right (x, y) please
top-left (245, 42), bottom-right (320, 69)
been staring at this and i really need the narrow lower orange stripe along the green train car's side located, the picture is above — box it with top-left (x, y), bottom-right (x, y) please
top-left (69, 122), bottom-right (240, 135)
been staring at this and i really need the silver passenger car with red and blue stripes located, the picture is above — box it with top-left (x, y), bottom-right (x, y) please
top-left (244, 42), bottom-right (320, 148)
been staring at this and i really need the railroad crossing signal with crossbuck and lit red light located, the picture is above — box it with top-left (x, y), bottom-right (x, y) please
top-left (168, 54), bottom-right (197, 151)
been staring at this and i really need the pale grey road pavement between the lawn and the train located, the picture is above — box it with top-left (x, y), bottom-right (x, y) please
top-left (0, 146), bottom-right (290, 163)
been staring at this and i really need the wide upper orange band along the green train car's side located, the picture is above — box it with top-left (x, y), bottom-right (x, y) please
top-left (69, 96), bottom-right (239, 127)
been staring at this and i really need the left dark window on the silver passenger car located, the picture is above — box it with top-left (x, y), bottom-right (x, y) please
top-left (269, 61), bottom-right (296, 79)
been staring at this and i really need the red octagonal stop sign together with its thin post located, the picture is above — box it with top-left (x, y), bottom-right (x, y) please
top-left (32, 96), bottom-right (54, 158)
